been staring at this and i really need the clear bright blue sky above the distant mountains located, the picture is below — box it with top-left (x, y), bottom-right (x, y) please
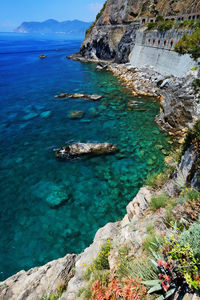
top-left (0, 0), bottom-right (105, 31)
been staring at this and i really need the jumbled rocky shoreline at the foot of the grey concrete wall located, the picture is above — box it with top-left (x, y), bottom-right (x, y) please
top-left (68, 53), bottom-right (200, 140)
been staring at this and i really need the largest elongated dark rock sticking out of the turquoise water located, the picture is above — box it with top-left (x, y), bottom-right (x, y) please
top-left (55, 143), bottom-right (118, 159)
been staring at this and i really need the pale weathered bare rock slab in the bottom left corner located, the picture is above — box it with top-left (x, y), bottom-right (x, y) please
top-left (0, 254), bottom-right (77, 300)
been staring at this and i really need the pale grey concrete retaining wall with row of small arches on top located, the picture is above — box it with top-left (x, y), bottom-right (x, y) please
top-left (129, 29), bottom-right (197, 77)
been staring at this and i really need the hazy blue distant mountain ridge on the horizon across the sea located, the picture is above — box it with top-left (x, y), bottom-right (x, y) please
top-left (13, 19), bottom-right (92, 35)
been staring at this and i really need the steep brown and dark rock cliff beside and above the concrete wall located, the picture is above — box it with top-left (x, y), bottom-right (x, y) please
top-left (80, 0), bottom-right (200, 63)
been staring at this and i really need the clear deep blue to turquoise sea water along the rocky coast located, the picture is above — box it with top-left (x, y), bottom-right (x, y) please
top-left (0, 34), bottom-right (168, 280)
